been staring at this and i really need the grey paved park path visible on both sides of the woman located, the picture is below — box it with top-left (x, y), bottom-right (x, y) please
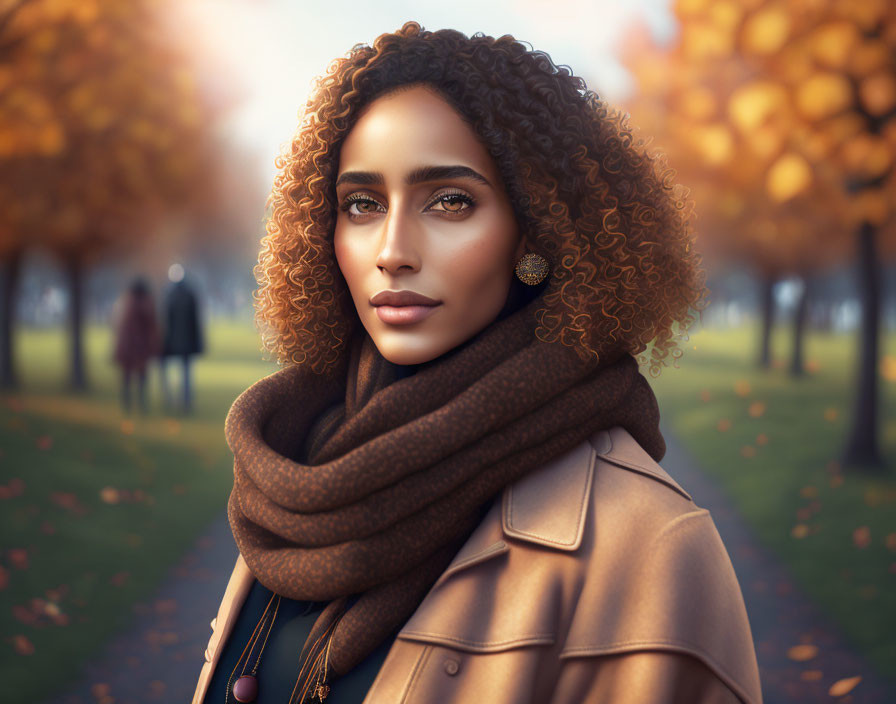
top-left (47, 428), bottom-right (896, 704)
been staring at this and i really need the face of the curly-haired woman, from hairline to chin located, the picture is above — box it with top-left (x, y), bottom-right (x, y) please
top-left (334, 86), bottom-right (525, 364)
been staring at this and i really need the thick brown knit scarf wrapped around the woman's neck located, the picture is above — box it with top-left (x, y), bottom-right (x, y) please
top-left (226, 299), bottom-right (665, 692)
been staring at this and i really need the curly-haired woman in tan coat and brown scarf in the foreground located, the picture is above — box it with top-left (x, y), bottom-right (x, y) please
top-left (194, 23), bottom-right (761, 704)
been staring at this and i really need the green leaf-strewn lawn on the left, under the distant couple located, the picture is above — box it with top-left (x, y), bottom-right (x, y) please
top-left (0, 322), bottom-right (275, 702)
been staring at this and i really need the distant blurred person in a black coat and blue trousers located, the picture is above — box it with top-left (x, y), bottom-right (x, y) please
top-left (162, 264), bottom-right (204, 413)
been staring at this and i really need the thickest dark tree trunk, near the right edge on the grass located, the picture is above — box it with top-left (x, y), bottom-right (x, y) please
top-left (842, 222), bottom-right (884, 471)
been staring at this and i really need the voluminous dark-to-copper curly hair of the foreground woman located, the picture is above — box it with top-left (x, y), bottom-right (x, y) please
top-left (255, 22), bottom-right (706, 376)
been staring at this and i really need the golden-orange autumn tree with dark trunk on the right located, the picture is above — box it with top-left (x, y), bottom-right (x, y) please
top-left (631, 0), bottom-right (896, 467)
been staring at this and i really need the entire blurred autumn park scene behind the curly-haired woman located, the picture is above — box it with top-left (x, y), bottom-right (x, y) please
top-left (0, 0), bottom-right (896, 704)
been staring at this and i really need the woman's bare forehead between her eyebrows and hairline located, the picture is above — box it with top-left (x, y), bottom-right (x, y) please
top-left (339, 86), bottom-right (496, 177)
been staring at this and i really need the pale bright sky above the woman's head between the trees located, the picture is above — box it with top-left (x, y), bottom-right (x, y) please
top-left (173, 0), bottom-right (674, 178)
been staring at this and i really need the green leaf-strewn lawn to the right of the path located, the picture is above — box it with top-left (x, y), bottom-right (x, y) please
top-left (652, 327), bottom-right (896, 673)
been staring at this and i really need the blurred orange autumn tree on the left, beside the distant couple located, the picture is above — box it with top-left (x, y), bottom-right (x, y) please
top-left (0, 0), bottom-right (231, 388)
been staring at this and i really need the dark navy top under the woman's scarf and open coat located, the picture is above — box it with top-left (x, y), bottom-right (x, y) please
top-left (203, 580), bottom-right (398, 704)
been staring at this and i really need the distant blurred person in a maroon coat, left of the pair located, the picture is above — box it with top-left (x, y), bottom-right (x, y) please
top-left (113, 278), bottom-right (161, 413)
